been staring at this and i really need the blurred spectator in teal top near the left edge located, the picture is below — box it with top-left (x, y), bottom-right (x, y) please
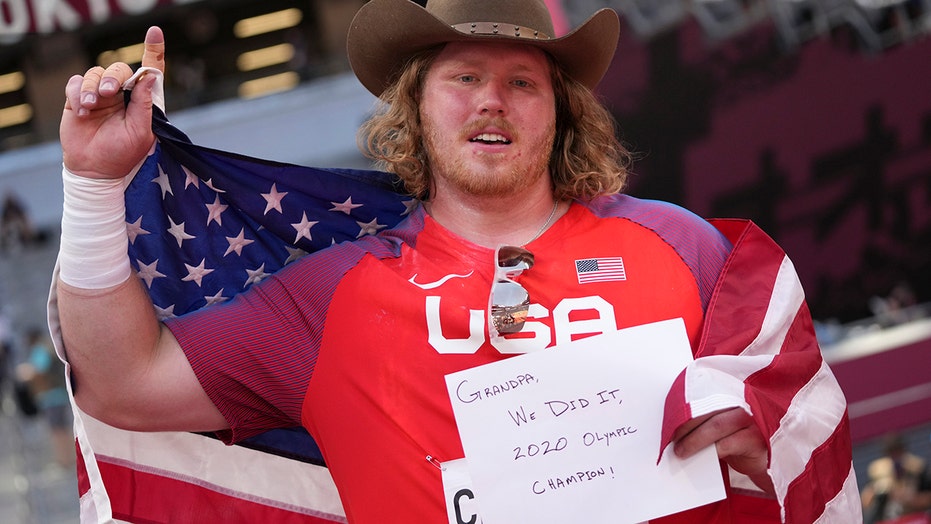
top-left (16, 328), bottom-right (75, 468)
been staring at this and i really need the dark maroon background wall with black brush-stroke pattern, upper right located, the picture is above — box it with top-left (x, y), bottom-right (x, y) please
top-left (600, 22), bottom-right (931, 321)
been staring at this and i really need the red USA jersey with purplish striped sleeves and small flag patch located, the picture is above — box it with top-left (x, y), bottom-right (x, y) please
top-left (168, 196), bottom-right (740, 523)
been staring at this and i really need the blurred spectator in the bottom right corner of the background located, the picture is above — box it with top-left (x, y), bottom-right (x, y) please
top-left (861, 434), bottom-right (931, 524)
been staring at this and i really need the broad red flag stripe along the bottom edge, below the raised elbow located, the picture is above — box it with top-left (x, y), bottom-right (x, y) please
top-left (97, 457), bottom-right (338, 524)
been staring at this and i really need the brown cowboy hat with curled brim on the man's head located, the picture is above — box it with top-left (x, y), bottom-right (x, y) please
top-left (347, 0), bottom-right (620, 96)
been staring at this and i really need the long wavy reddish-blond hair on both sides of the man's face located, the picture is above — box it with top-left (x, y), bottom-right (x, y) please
top-left (358, 48), bottom-right (631, 200)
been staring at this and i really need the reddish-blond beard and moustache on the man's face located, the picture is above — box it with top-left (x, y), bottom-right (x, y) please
top-left (423, 118), bottom-right (556, 197)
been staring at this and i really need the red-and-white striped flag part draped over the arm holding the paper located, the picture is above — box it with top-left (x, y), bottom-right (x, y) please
top-left (660, 220), bottom-right (862, 524)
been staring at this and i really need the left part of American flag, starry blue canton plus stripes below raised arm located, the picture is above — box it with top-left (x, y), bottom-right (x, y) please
top-left (64, 110), bottom-right (417, 523)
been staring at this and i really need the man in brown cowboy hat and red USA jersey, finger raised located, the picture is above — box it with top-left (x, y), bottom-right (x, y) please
top-left (57, 0), bottom-right (856, 522)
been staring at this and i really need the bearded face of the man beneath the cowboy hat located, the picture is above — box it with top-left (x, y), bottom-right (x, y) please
top-left (420, 43), bottom-right (556, 196)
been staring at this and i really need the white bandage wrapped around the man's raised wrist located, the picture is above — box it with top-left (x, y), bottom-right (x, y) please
top-left (58, 166), bottom-right (132, 289)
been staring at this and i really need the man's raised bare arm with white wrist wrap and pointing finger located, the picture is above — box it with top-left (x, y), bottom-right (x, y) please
top-left (57, 28), bottom-right (227, 431)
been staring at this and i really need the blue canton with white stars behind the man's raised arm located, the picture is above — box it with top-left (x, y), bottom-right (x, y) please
top-left (126, 109), bottom-right (417, 318)
